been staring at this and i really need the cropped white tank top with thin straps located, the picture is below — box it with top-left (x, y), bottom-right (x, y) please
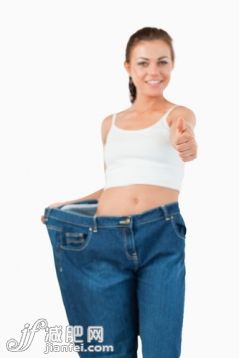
top-left (104, 105), bottom-right (184, 191)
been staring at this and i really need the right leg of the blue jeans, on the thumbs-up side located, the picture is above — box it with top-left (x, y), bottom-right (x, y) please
top-left (138, 214), bottom-right (186, 358)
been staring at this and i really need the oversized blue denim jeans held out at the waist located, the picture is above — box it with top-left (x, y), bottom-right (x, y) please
top-left (44, 199), bottom-right (187, 358)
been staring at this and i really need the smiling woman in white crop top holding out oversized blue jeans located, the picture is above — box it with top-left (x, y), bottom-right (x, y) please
top-left (42, 27), bottom-right (197, 358)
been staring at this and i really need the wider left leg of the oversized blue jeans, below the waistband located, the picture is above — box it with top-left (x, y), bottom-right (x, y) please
top-left (45, 221), bottom-right (138, 358)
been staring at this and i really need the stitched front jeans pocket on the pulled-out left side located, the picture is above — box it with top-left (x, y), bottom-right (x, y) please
top-left (60, 226), bottom-right (92, 251)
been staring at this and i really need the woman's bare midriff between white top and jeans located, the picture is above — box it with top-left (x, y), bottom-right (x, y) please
top-left (96, 184), bottom-right (179, 216)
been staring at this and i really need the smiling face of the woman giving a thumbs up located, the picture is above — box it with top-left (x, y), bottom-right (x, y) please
top-left (124, 40), bottom-right (173, 96)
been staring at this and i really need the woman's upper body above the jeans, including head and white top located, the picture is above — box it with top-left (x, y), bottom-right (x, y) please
top-left (96, 28), bottom-right (196, 216)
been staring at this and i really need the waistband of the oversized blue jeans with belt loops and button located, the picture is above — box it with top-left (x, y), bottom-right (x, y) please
top-left (44, 199), bottom-right (180, 231)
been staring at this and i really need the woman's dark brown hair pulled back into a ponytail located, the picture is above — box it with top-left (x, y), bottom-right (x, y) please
top-left (125, 27), bottom-right (175, 103)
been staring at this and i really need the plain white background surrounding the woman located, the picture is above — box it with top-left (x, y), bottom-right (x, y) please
top-left (0, 0), bottom-right (239, 358)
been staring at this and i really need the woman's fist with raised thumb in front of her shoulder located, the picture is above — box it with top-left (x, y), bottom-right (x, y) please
top-left (171, 116), bottom-right (197, 162)
